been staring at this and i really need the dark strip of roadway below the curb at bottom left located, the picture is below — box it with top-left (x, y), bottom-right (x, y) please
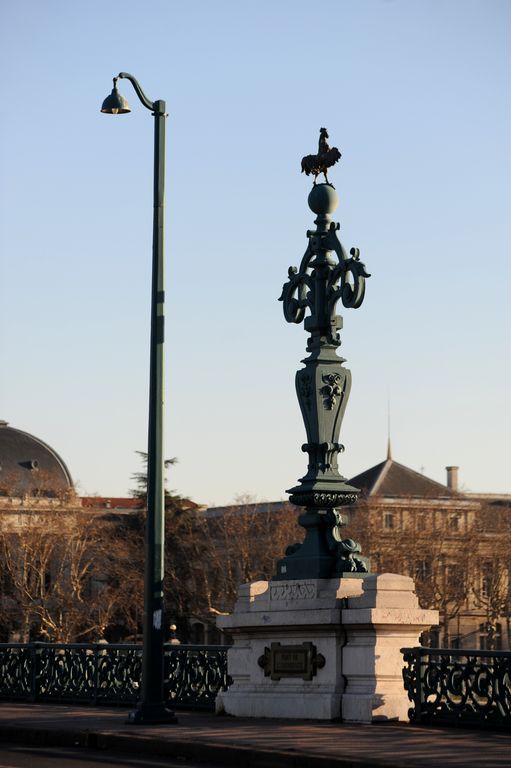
top-left (0, 744), bottom-right (221, 768)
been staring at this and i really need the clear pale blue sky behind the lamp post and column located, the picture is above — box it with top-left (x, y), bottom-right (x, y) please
top-left (0, 0), bottom-right (511, 505)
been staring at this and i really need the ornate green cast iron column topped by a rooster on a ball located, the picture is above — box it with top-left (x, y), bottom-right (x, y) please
top-left (275, 128), bottom-right (370, 579)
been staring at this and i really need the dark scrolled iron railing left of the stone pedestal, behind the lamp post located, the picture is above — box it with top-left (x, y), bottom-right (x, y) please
top-left (0, 643), bottom-right (230, 709)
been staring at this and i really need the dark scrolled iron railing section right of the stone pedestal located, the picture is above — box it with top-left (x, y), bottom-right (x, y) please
top-left (401, 648), bottom-right (511, 728)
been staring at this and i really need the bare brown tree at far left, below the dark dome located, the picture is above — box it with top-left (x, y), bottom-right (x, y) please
top-left (0, 507), bottom-right (144, 642)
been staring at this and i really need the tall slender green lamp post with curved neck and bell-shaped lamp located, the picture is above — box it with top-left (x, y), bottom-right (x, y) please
top-left (101, 72), bottom-right (177, 724)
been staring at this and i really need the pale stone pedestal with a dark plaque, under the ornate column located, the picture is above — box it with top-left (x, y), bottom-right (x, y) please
top-left (217, 574), bottom-right (438, 723)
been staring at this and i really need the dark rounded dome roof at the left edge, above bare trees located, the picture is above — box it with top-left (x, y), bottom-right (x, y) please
top-left (0, 421), bottom-right (73, 497)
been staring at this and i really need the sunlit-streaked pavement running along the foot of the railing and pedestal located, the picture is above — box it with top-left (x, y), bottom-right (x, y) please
top-left (0, 702), bottom-right (511, 768)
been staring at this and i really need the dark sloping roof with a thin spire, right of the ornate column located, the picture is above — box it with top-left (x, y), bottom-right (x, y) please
top-left (349, 458), bottom-right (459, 498)
